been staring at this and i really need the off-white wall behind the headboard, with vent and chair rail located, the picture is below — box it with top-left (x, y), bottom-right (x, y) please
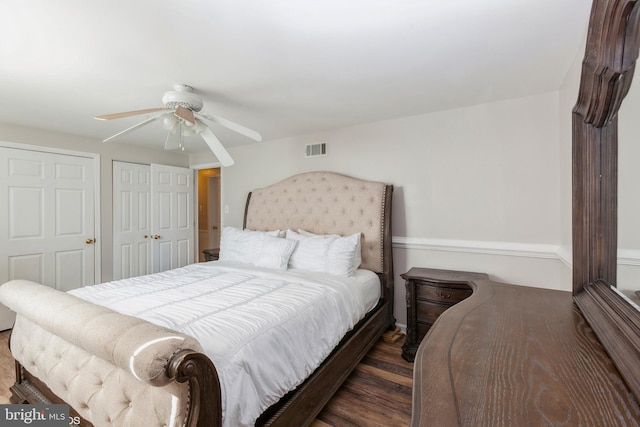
top-left (214, 92), bottom-right (571, 324)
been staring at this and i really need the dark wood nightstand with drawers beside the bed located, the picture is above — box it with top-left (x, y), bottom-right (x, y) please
top-left (400, 267), bottom-right (489, 362)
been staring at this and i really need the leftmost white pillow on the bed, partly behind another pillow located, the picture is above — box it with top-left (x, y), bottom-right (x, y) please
top-left (219, 227), bottom-right (280, 264)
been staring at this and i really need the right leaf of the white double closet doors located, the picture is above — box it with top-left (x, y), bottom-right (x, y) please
top-left (151, 165), bottom-right (195, 272)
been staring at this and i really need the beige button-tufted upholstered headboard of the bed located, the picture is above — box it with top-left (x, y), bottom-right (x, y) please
top-left (244, 172), bottom-right (392, 273)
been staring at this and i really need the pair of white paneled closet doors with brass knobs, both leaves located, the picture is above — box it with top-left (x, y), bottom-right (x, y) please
top-left (113, 162), bottom-right (194, 280)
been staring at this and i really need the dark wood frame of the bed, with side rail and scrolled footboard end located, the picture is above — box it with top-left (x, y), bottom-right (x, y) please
top-left (11, 172), bottom-right (395, 427)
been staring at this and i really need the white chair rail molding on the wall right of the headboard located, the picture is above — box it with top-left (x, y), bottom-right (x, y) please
top-left (392, 237), bottom-right (570, 265)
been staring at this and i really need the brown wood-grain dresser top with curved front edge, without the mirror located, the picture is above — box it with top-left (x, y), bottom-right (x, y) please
top-left (411, 280), bottom-right (640, 427)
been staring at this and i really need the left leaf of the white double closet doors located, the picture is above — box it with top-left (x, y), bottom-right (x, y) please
top-left (113, 162), bottom-right (152, 280)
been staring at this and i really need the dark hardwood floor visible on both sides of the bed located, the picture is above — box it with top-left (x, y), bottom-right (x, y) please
top-left (0, 331), bottom-right (413, 427)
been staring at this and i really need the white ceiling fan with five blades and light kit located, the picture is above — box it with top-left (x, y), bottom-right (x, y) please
top-left (95, 84), bottom-right (262, 166)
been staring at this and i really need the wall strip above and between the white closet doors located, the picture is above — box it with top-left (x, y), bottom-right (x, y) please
top-left (0, 123), bottom-right (189, 282)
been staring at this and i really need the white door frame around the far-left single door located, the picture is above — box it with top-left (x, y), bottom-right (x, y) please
top-left (0, 140), bottom-right (102, 284)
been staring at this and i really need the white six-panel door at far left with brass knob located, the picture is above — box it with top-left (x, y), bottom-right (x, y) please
top-left (0, 147), bottom-right (97, 329)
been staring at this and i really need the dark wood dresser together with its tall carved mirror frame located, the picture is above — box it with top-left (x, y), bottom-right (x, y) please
top-left (411, 0), bottom-right (640, 427)
